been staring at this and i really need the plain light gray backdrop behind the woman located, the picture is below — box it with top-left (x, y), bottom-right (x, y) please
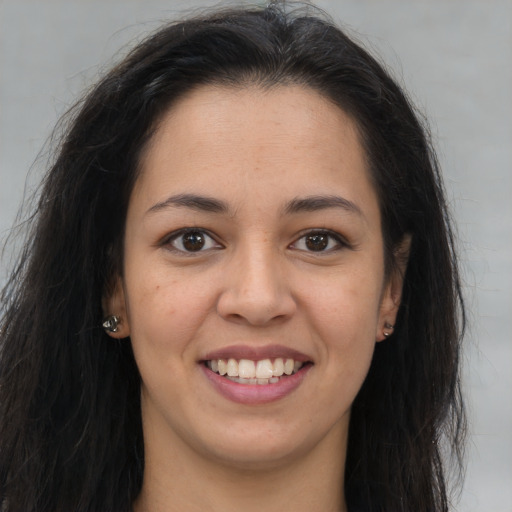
top-left (0, 0), bottom-right (512, 512)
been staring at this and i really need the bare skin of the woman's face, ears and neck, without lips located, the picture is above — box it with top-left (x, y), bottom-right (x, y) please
top-left (105, 86), bottom-right (402, 512)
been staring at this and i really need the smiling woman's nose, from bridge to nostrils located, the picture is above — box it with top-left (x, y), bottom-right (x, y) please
top-left (217, 244), bottom-right (297, 326)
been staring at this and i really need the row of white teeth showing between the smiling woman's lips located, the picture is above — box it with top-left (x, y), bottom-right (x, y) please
top-left (204, 357), bottom-right (312, 385)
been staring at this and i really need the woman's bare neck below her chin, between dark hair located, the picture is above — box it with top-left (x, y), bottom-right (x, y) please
top-left (134, 418), bottom-right (346, 512)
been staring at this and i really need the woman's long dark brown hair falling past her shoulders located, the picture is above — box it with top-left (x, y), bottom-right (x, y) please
top-left (0, 3), bottom-right (465, 512)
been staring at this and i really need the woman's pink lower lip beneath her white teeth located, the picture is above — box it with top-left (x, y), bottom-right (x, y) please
top-left (201, 364), bottom-right (313, 405)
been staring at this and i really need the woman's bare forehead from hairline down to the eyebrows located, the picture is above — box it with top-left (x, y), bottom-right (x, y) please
top-left (134, 85), bottom-right (375, 220)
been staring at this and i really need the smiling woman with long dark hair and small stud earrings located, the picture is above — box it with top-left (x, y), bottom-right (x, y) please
top-left (0, 5), bottom-right (464, 512)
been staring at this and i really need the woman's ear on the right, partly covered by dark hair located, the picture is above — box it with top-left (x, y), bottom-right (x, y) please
top-left (375, 235), bottom-right (411, 341)
